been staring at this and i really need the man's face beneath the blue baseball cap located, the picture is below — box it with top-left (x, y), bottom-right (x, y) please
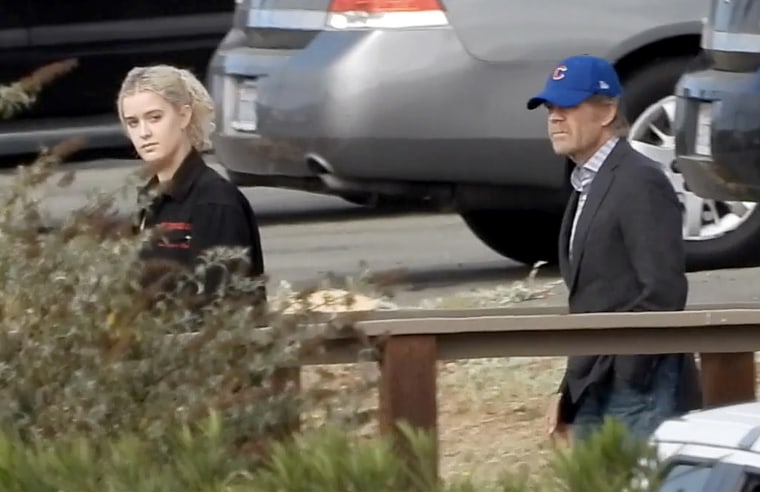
top-left (546, 101), bottom-right (616, 163)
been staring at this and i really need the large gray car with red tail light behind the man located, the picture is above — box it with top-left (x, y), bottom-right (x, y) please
top-left (209, 0), bottom-right (760, 269)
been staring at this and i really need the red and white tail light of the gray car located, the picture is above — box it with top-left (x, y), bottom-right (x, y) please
top-left (327, 0), bottom-right (449, 30)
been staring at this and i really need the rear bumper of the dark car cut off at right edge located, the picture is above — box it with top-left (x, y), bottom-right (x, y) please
top-left (675, 70), bottom-right (760, 201)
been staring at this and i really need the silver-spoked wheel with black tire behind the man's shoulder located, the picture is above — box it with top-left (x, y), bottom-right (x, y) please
top-left (624, 57), bottom-right (760, 271)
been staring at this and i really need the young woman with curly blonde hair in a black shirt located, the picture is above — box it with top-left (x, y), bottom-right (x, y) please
top-left (117, 65), bottom-right (264, 296)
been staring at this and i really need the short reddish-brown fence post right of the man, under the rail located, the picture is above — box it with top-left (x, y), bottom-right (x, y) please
top-left (699, 352), bottom-right (755, 408)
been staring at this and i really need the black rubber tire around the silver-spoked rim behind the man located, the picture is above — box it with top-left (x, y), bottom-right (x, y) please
top-left (623, 56), bottom-right (760, 271)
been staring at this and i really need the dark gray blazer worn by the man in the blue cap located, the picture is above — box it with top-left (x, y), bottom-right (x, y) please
top-left (559, 139), bottom-right (701, 422)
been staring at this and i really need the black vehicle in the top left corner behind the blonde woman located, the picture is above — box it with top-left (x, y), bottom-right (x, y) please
top-left (0, 0), bottom-right (235, 160)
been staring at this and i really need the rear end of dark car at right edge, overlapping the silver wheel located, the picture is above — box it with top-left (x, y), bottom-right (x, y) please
top-left (676, 0), bottom-right (760, 265)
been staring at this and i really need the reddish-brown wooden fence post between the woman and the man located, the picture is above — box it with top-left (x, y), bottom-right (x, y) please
top-left (379, 335), bottom-right (438, 477)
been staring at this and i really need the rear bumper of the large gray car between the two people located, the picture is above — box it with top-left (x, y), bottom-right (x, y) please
top-left (209, 28), bottom-right (563, 187)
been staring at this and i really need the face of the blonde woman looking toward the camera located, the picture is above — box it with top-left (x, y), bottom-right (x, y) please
top-left (121, 91), bottom-right (190, 168)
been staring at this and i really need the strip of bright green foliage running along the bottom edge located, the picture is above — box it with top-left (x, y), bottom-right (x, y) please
top-left (0, 414), bottom-right (658, 492)
